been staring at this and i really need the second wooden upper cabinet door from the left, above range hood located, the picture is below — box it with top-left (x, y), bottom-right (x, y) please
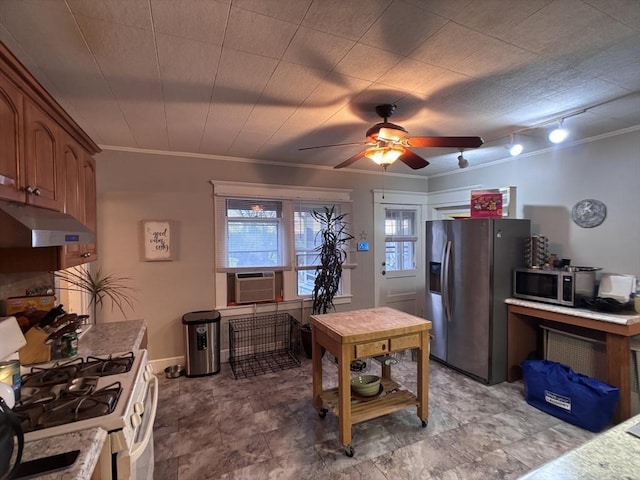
top-left (24, 99), bottom-right (64, 211)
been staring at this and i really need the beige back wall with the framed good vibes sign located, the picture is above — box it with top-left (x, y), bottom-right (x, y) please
top-left (96, 151), bottom-right (426, 360)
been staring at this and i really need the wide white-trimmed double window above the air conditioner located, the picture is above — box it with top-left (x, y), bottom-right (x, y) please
top-left (212, 182), bottom-right (352, 299)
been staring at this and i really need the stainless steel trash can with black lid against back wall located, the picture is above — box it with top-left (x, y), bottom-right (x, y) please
top-left (182, 310), bottom-right (220, 377)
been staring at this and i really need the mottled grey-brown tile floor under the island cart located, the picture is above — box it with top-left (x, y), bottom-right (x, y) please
top-left (154, 354), bottom-right (594, 480)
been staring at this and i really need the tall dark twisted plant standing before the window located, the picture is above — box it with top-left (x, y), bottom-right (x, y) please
top-left (302, 206), bottom-right (354, 358)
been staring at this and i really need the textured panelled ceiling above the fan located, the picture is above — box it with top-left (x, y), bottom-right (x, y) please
top-left (0, 0), bottom-right (640, 175)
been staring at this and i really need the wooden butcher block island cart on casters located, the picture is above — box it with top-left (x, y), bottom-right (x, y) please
top-left (311, 307), bottom-right (431, 457)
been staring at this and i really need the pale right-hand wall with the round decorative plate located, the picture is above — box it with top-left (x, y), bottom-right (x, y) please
top-left (428, 129), bottom-right (640, 277)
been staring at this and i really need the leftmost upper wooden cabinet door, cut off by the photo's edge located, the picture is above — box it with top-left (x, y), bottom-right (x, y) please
top-left (0, 75), bottom-right (25, 202)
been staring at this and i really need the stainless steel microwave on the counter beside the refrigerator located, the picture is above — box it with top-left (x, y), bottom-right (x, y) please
top-left (513, 268), bottom-right (596, 307)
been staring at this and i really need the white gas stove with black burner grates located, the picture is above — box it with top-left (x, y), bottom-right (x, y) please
top-left (13, 350), bottom-right (158, 479)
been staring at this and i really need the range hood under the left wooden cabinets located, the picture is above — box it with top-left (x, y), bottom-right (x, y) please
top-left (0, 201), bottom-right (96, 248)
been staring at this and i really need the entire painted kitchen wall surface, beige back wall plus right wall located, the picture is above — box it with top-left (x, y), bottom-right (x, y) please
top-left (97, 130), bottom-right (640, 360)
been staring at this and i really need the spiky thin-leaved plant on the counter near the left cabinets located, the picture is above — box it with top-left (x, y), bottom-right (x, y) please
top-left (53, 266), bottom-right (134, 323)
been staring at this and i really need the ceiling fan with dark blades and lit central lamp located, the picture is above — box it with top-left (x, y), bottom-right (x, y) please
top-left (299, 103), bottom-right (484, 170)
